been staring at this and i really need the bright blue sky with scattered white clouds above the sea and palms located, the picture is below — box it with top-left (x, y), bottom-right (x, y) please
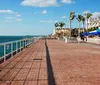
top-left (0, 0), bottom-right (100, 35)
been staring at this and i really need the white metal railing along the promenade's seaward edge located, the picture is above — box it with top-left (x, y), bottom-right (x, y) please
top-left (0, 37), bottom-right (36, 61)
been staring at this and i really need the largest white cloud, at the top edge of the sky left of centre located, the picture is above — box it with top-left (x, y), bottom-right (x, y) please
top-left (21, 0), bottom-right (58, 7)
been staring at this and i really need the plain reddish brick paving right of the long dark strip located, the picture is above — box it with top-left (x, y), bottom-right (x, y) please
top-left (48, 40), bottom-right (100, 85)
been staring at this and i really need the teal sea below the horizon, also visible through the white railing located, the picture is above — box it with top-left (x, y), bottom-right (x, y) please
top-left (0, 36), bottom-right (35, 57)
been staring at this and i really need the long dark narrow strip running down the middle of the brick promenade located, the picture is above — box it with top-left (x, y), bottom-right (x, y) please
top-left (45, 40), bottom-right (56, 85)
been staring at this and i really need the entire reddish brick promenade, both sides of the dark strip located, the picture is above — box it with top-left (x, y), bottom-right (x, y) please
top-left (0, 40), bottom-right (100, 85)
